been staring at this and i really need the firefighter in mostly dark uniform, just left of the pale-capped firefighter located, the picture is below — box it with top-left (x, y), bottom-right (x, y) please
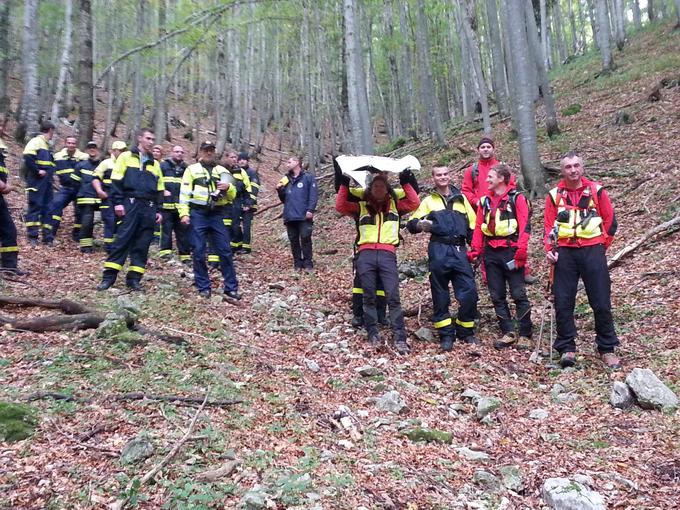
top-left (71, 142), bottom-right (101, 253)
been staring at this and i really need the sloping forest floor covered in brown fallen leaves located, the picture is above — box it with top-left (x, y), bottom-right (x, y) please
top-left (0, 20), bottom-right (680, 509)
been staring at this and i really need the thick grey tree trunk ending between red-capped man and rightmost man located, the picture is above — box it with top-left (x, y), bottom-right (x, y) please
top-left (504, 0), bottom-right (546, 196)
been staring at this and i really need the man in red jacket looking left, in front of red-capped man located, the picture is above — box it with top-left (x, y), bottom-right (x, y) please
top-left (468, 163), bottom-right (532, 349)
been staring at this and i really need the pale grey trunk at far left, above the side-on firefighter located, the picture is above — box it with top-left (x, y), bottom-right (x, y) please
top-left (15, 0), bottom-right (38, 141)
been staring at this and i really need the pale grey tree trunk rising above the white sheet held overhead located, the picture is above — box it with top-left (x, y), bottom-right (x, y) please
top-left (343, 0), bottom-right (373, 154)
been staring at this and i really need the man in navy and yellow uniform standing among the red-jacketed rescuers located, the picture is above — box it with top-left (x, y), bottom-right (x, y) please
top-left (407, 167), bottom-right (478, 351)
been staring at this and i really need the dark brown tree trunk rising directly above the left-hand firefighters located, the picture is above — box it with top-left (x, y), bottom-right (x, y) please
top-left (78, 0), bottom-right (94, 147)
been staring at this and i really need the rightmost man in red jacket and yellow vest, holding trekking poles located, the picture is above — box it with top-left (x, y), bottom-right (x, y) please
top-left (544, 152), bottom-right (621, 369)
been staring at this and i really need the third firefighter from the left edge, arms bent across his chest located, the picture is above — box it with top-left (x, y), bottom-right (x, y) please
top-left (48, 136), bottom-right (88, 241)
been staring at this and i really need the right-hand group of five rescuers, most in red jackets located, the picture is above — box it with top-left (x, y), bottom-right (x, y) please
top-left (336, 137), bottom-right (620, 369)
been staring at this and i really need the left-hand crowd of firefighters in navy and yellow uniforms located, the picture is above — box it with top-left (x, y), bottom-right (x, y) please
top-left (5, 121), bottom-right (260, 300)
